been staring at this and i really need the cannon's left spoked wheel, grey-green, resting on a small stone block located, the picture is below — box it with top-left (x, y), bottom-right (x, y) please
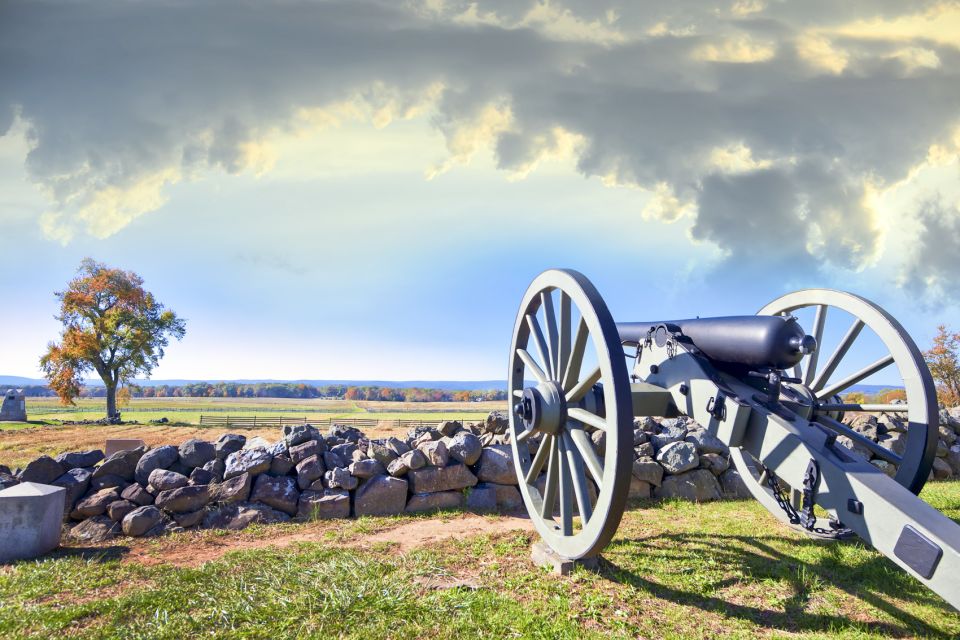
top-left (508, 269), bottom-right (633, 559)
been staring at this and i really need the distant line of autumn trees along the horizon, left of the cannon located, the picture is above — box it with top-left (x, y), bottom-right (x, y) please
top-left (16, 382), bottom-right (507, 402)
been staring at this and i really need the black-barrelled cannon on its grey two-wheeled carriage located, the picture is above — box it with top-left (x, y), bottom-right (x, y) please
top-left (508, 269), bottom-right (960, 608)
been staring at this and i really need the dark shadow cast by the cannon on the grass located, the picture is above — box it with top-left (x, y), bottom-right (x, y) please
top-left (598, 533), bottom-right (956, 638)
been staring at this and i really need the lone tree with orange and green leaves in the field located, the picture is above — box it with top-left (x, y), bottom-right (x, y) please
top-left (40, 258), bottom-right (186, 418)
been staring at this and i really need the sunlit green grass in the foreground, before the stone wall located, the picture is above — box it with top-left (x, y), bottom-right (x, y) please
top-left (0, 482), bottom-right (960, 639)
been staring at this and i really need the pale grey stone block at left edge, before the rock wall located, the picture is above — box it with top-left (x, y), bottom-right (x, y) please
top-left (0, 482), bottom-right (67, 562)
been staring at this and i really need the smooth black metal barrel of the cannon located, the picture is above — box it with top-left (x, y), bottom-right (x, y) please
top-left (617, 316), bottom-right (816, 369)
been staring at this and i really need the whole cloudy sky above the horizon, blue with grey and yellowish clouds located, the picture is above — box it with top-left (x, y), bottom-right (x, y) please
top-left (0, 0), bottom-right (960, 380)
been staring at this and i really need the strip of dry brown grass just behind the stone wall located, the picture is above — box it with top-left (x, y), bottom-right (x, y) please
top-left (0, 425), bottom-right (402, 469)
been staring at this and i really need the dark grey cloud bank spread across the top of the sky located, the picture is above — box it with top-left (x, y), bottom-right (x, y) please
top-left (0, 0), bottom-right (960, 290)
